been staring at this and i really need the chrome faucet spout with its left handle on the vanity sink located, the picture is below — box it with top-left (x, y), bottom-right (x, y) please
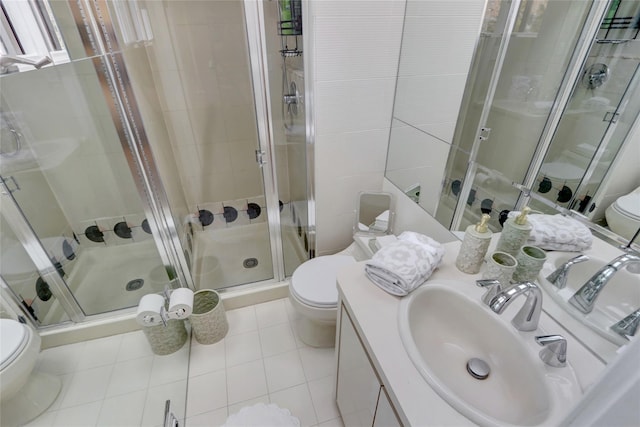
top-left (489, 282), bottom-right (542, 331)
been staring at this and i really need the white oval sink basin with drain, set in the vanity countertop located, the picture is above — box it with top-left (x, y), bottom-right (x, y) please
top-left (399, 280), bottom-right (581, 426)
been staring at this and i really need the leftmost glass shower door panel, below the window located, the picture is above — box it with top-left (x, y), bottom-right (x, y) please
top-left (0, 58), bottom-right (169, 324)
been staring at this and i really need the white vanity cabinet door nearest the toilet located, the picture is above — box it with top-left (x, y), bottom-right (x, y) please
top-left (336, 307), bottom-right (380, 427)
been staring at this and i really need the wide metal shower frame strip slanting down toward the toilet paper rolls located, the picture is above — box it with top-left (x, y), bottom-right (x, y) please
top-left (68, 0), bottom-right (195, 289)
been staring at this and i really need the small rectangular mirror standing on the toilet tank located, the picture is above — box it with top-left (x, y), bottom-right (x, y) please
top-left (356, 192), bottom-right (393, 235)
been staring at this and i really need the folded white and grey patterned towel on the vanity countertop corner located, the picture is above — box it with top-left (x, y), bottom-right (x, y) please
top-left (364, 232), bottom-right (444, 296)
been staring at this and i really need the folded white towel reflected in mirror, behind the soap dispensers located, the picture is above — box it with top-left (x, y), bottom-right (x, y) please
top-left (509, 212), bottom-right (593, 252)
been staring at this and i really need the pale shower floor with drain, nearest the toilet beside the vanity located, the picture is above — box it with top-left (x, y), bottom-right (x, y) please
top-left (193, 222), bottom-right (306, 289)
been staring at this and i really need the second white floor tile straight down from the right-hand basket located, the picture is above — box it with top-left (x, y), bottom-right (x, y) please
top-left (187, 370), bottom-right (227, 418)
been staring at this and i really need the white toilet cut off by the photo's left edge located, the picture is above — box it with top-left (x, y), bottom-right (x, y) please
top-left (0, 319), bottom-right (62, 427)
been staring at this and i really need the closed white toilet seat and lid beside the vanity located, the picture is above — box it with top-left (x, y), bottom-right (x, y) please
top-left (290, 255), bottom-right (356, 308)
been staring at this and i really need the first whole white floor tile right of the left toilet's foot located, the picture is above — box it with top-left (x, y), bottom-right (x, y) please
top-left (60, 365), bottom-right (113, 408)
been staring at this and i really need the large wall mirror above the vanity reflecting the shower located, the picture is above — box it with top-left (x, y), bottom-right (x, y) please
top-left (385, 0), bottom-right (640, 241)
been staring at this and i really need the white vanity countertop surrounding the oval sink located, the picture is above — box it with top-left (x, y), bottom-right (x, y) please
top-left (337, 242), bottom-right (605, 426)
